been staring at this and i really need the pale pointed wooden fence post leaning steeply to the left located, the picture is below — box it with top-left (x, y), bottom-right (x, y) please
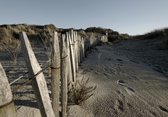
top-left (20, 32), bottom-right (54, 117)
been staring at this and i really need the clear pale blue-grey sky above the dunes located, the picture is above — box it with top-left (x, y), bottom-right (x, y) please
top-left (0, 0), bottom-right (168, 34)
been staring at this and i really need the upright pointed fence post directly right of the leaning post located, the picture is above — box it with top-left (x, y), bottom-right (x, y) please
top-left (51, 32), bottom-right (60, 117)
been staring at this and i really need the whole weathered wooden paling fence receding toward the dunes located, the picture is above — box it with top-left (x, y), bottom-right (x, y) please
top-left (0, 30), bottom-right (106, 117)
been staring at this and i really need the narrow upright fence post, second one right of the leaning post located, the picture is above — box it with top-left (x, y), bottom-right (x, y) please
top-left (61, 34), bottom-right (68, 117)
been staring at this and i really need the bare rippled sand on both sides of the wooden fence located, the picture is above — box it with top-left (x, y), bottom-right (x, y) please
top-left (3, 40), bottom-right (168, 117)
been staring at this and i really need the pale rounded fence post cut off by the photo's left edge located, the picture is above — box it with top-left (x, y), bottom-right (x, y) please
top-left (0, 64), bottom-right (16, 117)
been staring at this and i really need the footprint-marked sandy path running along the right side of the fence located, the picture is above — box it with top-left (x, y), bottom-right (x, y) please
top-left (69, 43), bottom-right (168, 117)
